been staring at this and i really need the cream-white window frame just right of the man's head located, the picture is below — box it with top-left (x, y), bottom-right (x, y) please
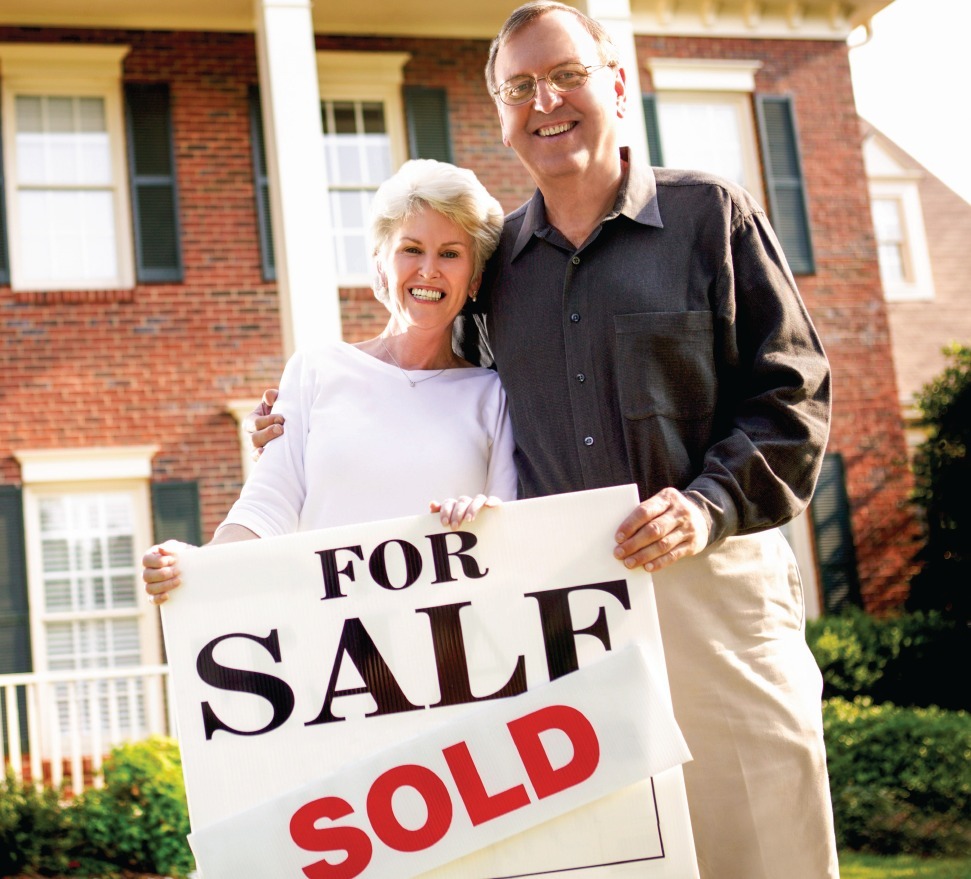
top-left (647, 58), bottom-right (765, 204)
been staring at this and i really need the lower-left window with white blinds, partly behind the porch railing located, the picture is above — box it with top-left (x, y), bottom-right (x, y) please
top-left (16, 447), bottom-right (161, 736)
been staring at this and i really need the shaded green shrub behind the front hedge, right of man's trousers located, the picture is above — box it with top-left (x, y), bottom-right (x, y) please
top-left (806, 608), bottom-right (971, 710)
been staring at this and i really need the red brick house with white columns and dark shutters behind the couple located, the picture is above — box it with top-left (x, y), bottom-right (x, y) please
top-left (0, 0), bottom-right (915, 784)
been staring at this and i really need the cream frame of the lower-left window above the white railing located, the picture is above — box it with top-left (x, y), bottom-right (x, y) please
top-left (14, 454), bottom-right (162, 688)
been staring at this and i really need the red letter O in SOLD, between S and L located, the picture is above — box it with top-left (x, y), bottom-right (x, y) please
top-left (367, 764), bottom-right (452, 852)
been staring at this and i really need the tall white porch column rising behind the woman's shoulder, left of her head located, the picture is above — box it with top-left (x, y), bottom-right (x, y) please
top-left (254, 0), bottom-right (341, 356)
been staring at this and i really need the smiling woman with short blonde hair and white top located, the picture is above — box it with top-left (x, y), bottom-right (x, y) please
top-left (142, 160), bottom-right (517, 604)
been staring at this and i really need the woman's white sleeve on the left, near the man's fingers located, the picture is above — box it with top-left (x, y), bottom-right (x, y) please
top-left (217, 352), bottom-right (314, 537)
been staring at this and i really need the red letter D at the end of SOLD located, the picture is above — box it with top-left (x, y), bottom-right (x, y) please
top-left (507, 705), bottom-right (600, 800)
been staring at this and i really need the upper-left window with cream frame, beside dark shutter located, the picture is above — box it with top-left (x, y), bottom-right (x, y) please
top-left (0, 44), bottom-right (134, 290)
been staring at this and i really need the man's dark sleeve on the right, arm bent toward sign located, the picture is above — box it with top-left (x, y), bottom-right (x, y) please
top-left (686, 211), bottom-right (831, 543)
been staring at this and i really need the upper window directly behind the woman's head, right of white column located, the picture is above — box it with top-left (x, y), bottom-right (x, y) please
top-left (317, 52), bottom-right (410, 286)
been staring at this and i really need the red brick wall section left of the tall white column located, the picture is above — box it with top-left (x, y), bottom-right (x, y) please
top-left (0, 29), bottom-right (283, 535)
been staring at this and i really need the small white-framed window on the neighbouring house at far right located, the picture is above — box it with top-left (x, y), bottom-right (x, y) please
top-left (863, 134), bottom-right (934, 302)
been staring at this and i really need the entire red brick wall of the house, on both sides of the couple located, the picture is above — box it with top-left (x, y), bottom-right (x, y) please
top-left (0, 28), bottom-right (915, 609)
